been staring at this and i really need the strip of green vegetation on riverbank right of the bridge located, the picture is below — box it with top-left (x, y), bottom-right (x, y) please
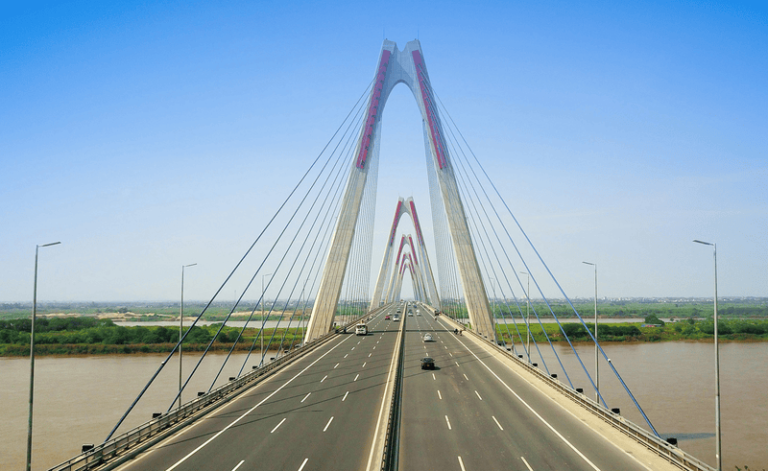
top-left (496, 319), bottom-right (768, 342)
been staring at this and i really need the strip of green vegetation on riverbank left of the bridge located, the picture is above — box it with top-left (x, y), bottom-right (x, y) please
top-left (0, 317), bottom-right (306, 356)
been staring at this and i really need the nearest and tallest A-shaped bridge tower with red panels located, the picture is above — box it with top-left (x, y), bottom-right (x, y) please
top-left (306, 40), bottom-right (495, 341)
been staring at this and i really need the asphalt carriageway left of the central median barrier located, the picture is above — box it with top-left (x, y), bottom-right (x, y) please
top-left (115, 306), bottom-right (399, 471)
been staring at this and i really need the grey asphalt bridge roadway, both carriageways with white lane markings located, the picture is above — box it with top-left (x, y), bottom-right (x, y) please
top-left (112, 305), bottom-right (677, 471)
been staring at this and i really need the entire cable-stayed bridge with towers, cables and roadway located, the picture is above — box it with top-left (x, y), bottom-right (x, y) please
top-left (55, 41), bottom-right (711, 471)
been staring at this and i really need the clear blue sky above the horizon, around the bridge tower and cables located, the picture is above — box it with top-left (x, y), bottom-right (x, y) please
top-left (0, 1), bottom-right (768, 302)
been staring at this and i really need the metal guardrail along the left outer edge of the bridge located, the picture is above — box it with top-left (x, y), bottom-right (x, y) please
top-left (49, 307), bottom-right (382, 471)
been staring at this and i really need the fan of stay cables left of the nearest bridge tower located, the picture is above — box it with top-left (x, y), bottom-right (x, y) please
top-left (105, 82), bottom-right (378, 442)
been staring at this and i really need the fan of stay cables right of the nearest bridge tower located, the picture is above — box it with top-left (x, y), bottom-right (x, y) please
top-left (414, 65), bottom-right (658, 435)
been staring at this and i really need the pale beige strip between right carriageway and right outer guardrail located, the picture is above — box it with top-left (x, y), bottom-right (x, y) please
top-left (437, 315), bottom-right (680, 471)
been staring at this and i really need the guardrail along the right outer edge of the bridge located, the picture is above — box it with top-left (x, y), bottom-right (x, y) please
top-left (433, 311), bottom-right (716, 471)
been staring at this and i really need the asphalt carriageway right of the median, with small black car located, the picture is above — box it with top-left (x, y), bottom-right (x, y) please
top-left (400, 312), bottom-right (647, 471)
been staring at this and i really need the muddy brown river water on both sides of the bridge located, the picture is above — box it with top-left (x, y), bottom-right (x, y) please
top-left (0, 342), bottom-right (768, 470)
